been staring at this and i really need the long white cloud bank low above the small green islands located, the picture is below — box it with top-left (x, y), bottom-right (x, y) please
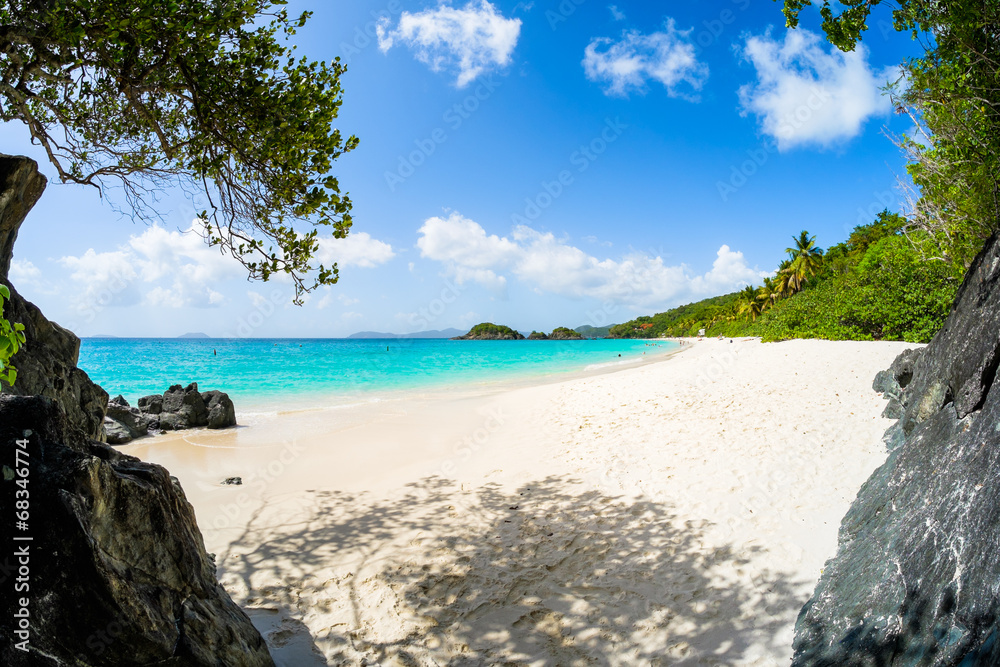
top-left (417, 213), bottom-right (766, 308)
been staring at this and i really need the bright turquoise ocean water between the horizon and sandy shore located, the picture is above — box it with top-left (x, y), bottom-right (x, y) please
top-left (79, 338), bottom-right (677, 411)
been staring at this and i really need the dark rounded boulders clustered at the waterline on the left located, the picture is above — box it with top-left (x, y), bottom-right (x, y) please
top-left (138, 382), bottom-right (236, 431)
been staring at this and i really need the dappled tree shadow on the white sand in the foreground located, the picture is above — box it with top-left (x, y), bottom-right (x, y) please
top-left (220, 477), bottom-right (802, 666)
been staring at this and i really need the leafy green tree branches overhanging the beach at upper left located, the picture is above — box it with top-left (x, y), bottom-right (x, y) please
top-left (0, 0), bottom-right (358, 303)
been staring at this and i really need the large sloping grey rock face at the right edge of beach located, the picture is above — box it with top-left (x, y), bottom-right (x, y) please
top-left (793, 231), bottom-right (1000, 667)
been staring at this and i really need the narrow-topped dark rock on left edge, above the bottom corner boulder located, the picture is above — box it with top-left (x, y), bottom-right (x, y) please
top-left (0, 155), bottom-right (108, 441)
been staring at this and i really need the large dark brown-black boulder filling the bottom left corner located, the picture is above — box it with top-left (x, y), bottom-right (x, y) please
top-left (0, 396), bottom-right (274, 667)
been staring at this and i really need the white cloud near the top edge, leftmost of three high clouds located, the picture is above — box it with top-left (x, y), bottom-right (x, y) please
top-left (377, 0), bottom-right (521, 88)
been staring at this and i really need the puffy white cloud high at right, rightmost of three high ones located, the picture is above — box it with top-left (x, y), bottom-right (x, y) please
top-left (739, 29), bottom-right (898, 150)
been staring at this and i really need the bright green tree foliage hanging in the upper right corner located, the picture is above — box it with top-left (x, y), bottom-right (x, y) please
top-left (785, 0), bottom-right (1000, 267)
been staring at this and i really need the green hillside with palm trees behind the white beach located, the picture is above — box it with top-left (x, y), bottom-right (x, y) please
top-left (611, 211), bottom-right (964, 342)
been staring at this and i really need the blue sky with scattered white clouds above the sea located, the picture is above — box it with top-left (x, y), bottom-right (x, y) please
top-left (0, 0), bottom-right (920, 337)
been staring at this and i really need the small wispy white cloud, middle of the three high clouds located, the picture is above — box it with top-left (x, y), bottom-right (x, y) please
top-left (583, 19), bottom-right (708, 99)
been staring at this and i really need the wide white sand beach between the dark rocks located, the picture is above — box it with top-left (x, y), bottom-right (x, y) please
top-left (121, 340), bottom-right (913, 666)
